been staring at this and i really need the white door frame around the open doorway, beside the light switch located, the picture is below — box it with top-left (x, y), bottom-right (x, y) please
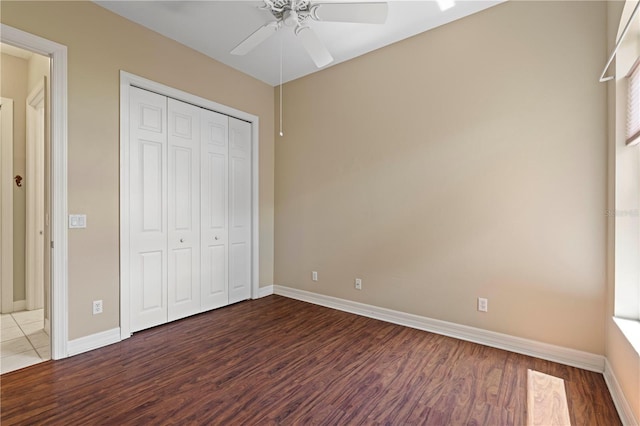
top-left (0, 24), bottom-right (69, 359)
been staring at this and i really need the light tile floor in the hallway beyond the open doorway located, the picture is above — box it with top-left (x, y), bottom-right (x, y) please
top-left (0, 309), bottom-right (51, 374)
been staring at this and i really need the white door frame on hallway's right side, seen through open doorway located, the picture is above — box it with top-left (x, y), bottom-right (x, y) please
top-left (25, 79), bottom-right (45, 310)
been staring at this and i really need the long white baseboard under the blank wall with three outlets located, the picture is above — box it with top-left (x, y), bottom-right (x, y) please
top-left (273, 285), bottom-right (605, 373)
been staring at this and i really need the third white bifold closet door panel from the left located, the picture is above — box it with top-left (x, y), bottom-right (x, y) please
top-left (200, 109), bottom-right (229, 311)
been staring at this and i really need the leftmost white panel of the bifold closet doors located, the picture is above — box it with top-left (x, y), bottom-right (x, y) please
top-left (129, 87), bottom-right (167, 332)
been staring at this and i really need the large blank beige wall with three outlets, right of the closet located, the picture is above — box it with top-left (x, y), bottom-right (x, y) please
top-left (274, 1), bottom-right (606, 354)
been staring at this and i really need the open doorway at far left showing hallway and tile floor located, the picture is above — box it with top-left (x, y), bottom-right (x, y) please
top-left (0, 44), bottom-right (51, 373)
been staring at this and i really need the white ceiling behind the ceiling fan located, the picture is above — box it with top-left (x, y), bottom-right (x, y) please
top-left (94, 0), bottom-right (505, 86)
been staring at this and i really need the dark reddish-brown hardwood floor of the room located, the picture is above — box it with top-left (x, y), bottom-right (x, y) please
top-left (0, 296), bottom-right (620, 426)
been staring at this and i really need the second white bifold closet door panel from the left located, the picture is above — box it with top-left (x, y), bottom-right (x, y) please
top-left (168, 99), bottom-right (200, 321)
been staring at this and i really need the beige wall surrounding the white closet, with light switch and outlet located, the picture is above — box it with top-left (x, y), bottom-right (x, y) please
top-left (1, 1), bottom-right (274, 339)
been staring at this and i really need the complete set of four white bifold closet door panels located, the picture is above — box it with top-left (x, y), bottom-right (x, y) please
top-left (124, 83), bottom-right (253, 332)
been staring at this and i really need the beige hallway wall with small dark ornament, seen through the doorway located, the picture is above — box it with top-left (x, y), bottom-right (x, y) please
top-left (0, 53), bottom-right (28, 301)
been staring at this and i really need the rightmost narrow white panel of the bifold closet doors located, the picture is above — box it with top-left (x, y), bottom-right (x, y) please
top-left (229, 117), bottom-right (251, 303)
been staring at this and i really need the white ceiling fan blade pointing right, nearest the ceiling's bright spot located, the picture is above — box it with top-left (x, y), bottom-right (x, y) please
top-left (311, 2), bottom-right (388, 24)
